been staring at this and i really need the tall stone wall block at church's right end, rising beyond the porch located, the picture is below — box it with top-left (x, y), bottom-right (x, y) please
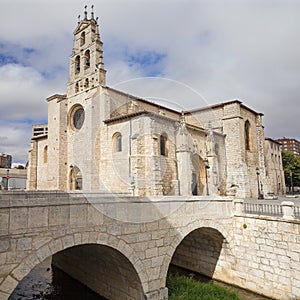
top-left (188, 101), bottom-right (265, 198)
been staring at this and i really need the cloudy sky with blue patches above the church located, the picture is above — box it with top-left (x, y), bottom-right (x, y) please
top-left (0, 0), bottom-right (300, 164)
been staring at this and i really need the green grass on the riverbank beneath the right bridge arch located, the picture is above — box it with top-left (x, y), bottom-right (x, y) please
top-left (167, 274), bottom-right (240, 300)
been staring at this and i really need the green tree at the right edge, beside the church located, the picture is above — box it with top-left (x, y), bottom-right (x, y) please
top-left (282, 152), bottom-right (300, 192)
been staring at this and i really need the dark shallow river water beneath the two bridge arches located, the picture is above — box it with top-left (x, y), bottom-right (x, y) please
top-left (9, 259), bottom-right (269, 300)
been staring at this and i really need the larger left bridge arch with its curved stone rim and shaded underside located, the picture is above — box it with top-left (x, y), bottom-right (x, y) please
top-left (5, 231), bottom-right (148, 299)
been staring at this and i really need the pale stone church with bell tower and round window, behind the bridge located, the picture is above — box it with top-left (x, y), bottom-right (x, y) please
top-left (27, 8), bottom-right (285, 198)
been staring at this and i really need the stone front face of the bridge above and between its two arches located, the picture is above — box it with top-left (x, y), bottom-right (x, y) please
top-left (0, 192), bottom-right (231, 300)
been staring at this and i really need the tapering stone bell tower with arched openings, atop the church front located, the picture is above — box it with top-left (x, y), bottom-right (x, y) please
top-left (67, 5), bottom-right (106, 97)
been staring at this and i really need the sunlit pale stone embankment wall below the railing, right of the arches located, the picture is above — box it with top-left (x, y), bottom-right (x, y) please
top-left (233, 216), bottom-right (300, 299)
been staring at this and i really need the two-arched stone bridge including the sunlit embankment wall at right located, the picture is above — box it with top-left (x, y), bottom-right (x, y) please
top-left (0, 191), bottom-right (300, 299)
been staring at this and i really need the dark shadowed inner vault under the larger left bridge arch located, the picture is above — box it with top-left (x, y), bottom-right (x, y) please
top-left (52, 244), bottom-right (144, 299)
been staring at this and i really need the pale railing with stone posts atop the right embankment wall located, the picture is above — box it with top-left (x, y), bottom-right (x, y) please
top-left (234, 199), bottom-right (300, 220)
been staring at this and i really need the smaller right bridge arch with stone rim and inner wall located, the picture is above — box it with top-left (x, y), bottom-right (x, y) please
top-left (161, 220), bottom-right (235, 286)
